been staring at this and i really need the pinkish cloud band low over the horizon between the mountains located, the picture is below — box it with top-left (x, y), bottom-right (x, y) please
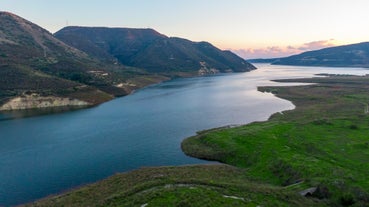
top-left (232, 39), bottom-right (335, 59)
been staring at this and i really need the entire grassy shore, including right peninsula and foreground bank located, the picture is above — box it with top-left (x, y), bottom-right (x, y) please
top-left (25, 76), bottom-right (369, 206)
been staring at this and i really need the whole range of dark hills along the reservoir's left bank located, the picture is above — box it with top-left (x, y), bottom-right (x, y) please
top-left (0, 12), bottom-right (255, 110)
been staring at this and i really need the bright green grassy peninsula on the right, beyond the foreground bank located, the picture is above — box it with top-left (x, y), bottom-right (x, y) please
top-left (182, 76), bottom-right (369, 206)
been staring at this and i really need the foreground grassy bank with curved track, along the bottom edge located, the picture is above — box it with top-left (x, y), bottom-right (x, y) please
top-left (28, 165), bottom-right (315, 207)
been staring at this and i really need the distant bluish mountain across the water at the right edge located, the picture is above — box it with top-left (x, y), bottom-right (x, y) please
top-left (272, 42), bottom-right (369, 67)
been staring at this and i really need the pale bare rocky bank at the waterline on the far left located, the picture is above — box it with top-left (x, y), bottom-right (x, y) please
top-left (0, 94), bottom-right (91, 111)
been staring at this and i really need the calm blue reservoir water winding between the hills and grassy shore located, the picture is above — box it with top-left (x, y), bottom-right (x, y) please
top-left (0, 64), bottom-right (369, 206)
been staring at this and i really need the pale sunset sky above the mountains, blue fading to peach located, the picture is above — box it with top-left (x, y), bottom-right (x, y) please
top-left (0, 0), bottom-right (369, 59)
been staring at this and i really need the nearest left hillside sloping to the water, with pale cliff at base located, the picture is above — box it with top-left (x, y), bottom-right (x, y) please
top-left (0, 12), bottom-right (168, 110)
